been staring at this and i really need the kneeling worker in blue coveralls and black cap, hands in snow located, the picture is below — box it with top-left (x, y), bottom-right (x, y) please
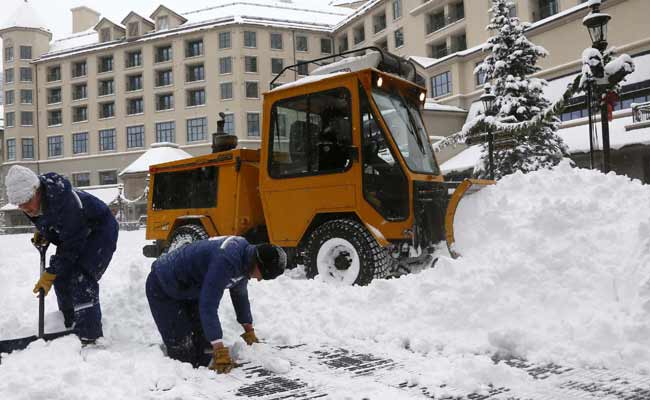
top-left (146, 236), bottom-right (287, 373)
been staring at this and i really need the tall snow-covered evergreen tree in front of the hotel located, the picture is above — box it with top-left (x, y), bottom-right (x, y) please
top-left (475, 0), bottom-right (567, 179)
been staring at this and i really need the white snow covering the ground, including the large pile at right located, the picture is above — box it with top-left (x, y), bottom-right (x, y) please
top-left (0, 164), bottom-right (650, 400)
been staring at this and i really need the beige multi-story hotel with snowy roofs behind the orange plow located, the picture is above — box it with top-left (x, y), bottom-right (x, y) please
top-left (0, 0), bottom-right (650, 212)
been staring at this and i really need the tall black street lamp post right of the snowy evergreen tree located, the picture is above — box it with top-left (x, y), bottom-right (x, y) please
top-left (582, 0), bottom-right (612, 173)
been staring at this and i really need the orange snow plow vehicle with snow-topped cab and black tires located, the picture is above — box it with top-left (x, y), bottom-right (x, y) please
top-left (140, 49), bottom-right (486, 285)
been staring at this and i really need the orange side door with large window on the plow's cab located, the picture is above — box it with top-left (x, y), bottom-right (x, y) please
top-left (260, 79), bottom-right (360, 247)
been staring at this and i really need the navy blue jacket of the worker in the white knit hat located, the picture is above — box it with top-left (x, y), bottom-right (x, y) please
top-left (30, 172), bottom-right (119, 275)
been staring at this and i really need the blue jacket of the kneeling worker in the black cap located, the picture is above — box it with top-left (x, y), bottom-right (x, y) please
top-left (152, 236), bottom-right (255, 342)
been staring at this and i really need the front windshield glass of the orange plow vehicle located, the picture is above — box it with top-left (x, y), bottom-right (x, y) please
top-left (372, 88), bottom-right (440, 175)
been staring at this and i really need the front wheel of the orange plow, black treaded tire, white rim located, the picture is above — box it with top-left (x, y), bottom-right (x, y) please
top-left (304, 219), bottom-right (391, 286)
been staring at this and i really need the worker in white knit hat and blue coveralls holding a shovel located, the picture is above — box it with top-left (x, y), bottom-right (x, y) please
top-left (5, 165), bottom-right (119, 345)
